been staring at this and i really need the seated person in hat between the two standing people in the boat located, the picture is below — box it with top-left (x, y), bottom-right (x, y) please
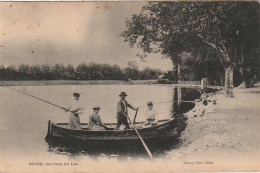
top-left (88, 106), bottom-right (107, 130)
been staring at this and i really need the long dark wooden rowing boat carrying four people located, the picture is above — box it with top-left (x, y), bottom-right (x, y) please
top-left (47, 119), bottom-right (176, 144)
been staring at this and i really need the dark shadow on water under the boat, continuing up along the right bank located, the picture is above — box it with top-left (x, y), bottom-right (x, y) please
top-left (47, 87), bottom-right (217, 160)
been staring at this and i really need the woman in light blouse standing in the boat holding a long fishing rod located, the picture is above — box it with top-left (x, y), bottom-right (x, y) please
top-left (63, 92), bottom-right (84, 130)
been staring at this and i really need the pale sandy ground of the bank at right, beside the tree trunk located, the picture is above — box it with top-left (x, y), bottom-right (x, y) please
top-left (167, 85), bottom-right (260, 171)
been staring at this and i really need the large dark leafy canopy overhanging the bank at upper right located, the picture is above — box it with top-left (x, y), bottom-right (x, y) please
top-left (121, 2), bottom-right (260, 87)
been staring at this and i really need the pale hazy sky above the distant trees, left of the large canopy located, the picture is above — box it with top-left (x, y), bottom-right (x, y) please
top-left (0, 2), bottom-right (172, 71)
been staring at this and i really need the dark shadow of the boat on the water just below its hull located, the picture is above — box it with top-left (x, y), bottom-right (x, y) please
top-left (48, 138), bottom-right (179, 160)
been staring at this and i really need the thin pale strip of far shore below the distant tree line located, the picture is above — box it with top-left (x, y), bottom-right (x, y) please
top-left (0, 79), bottom-right (223, 90)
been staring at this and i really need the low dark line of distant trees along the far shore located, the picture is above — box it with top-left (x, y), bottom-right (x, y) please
top-left (0, 62), bottom-right (163, 80)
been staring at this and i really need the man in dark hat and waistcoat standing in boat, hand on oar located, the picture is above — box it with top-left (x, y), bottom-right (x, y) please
top-left (115, 92), bottom-right (137, 130)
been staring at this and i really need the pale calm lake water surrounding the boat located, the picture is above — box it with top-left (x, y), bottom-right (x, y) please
top-left (0, 85), bottom-right (203, 160)
